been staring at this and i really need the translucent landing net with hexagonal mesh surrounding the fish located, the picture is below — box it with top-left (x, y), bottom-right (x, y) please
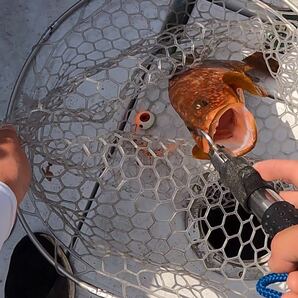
top-left (8, 0), bottom-right (298, 297)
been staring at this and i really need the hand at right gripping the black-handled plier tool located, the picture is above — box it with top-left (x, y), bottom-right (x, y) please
top-left (255, 160), bottom-right (298, 298)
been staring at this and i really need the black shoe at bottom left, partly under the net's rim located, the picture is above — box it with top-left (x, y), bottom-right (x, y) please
top-left (5, 233), bottom-right (75, 298)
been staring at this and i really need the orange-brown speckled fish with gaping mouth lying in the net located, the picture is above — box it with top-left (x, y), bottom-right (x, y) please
top-left (168, 60), bottom-right (267, 159)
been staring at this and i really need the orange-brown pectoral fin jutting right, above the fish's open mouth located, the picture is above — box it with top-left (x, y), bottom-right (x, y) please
top-left (223, 71), bottom-right (267, 96)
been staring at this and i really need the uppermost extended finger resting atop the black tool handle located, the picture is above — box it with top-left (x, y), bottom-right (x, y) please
top-left (254, 159), bottom-right (298, 185)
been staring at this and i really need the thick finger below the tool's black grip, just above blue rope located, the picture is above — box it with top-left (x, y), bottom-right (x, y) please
top-left (269, 225), bottom-right (298, 273)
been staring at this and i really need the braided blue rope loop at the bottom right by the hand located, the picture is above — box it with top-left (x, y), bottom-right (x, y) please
top-left (256, 273), bottom-right (288, 298)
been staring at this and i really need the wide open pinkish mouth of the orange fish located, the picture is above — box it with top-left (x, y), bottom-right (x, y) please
top-left (209, 103), bottom-right (257, 156)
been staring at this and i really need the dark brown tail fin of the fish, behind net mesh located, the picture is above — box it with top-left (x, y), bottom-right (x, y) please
top-left (242, 52), bottom-right (279, 75)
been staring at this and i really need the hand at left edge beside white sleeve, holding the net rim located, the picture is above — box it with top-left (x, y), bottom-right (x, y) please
top-left (0, 126), bottom-right (31, 205)
